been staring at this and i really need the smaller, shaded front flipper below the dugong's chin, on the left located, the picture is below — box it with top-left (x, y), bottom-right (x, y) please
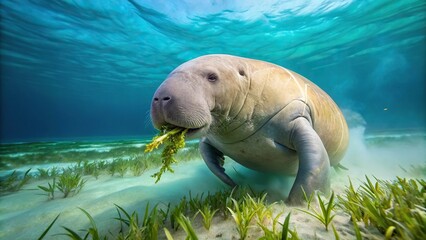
top-left (200, 138), bottom-right (237, 187)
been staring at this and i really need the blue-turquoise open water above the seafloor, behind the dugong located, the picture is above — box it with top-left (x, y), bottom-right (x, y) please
top-left (0, 0), bottom-right (426, 142)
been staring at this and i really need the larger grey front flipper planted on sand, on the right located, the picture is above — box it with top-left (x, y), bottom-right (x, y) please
top-left (287, 117), bottom-right (332, 204)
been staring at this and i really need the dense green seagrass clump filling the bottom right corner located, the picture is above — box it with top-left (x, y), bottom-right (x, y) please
top-left (339, 177), bottom-right (426, 239)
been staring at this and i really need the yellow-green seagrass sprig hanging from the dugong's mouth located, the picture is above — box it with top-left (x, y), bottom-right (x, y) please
top-left (145, 128), bottom-right (188, 183)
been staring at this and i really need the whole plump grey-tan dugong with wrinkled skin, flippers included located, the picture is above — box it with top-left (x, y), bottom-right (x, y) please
top-left (151, 55), bottom-right (349, 203)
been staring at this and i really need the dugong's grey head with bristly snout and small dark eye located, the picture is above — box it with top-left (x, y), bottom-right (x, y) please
top-left (151, 55), bottom-right (249, 138)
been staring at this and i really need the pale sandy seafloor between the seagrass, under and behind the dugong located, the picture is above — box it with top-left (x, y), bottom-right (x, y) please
top-left (0, 128), bottom-right (426, 239)
